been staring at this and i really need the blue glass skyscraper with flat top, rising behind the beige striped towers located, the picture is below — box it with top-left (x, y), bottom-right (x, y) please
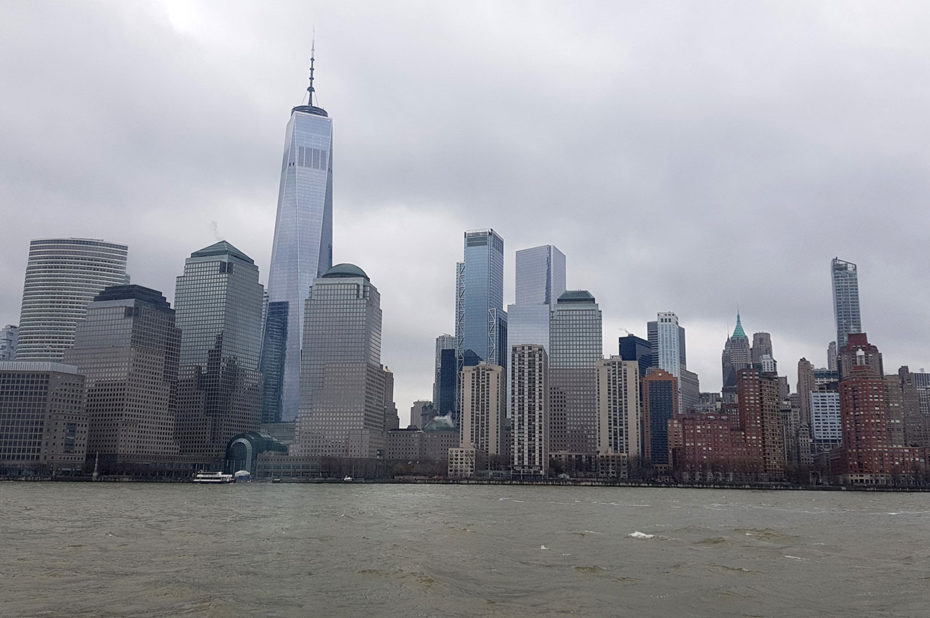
top-left (455, 229), bottom-right (507, 367)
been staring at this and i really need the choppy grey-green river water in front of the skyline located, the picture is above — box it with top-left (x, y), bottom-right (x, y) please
top-left (0, 483), bottom-right (930, 616)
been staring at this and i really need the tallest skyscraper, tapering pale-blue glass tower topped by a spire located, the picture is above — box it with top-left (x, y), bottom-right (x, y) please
top-left (265, 54), bottom-right (333, 421)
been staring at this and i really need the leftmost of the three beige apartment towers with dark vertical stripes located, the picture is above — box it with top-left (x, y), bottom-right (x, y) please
top-left (460, 362), bottom-right (505, 456)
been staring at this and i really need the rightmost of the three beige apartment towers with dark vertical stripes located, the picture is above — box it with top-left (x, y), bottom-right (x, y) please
top-left (597, 356), bottom-right (642, 458)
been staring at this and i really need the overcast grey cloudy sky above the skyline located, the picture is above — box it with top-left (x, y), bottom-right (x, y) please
top-left (0, 0), bottom-right (930, 424)
